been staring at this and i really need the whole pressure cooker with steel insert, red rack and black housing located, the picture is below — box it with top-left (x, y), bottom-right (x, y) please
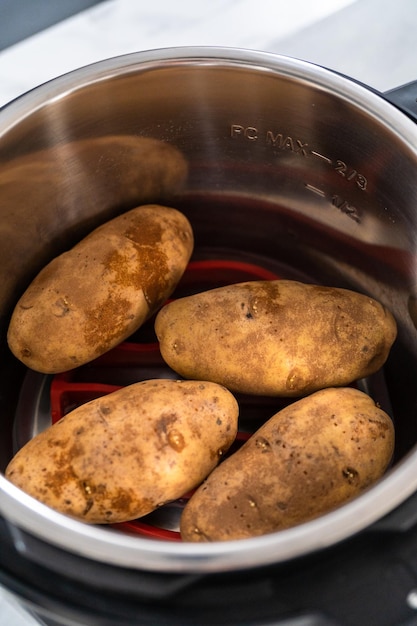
top-left (0, 48), bottom-right (417, 626)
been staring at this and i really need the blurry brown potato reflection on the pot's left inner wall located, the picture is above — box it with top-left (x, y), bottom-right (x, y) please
top-left (0, 133), bottom-right (188, 311)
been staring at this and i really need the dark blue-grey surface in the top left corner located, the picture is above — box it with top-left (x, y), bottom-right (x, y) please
top-left (0, 0), bottom-right (103, 50)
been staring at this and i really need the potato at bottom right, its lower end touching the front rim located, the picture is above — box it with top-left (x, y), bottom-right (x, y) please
top-left (181, 387), bottom-right (394, 542)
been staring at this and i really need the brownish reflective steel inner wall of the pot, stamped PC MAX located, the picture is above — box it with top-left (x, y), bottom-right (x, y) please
top-left (0, 54), bottom-right (417, 516)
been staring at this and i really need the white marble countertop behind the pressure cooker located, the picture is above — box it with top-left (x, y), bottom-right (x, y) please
top-left (0, 0), bottom-right (417, 626)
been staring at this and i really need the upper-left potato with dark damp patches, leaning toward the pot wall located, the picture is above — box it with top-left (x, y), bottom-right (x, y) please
top-left (8, 205), bottom-right (193, 373)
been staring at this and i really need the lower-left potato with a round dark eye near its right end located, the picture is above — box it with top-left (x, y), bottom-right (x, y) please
top-left (6, 379), bottom-right (238, 524)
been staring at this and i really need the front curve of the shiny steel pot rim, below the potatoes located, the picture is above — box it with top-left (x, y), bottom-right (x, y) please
top-left (0, 452), bottom-right (417, 574)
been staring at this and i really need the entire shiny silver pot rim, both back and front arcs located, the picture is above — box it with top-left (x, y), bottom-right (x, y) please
top-left (0, 47), bottom-right (417, 573)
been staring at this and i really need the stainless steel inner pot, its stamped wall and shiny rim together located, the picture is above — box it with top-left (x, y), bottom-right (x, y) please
top-left (0, 48), bottom-right (417, 572)
